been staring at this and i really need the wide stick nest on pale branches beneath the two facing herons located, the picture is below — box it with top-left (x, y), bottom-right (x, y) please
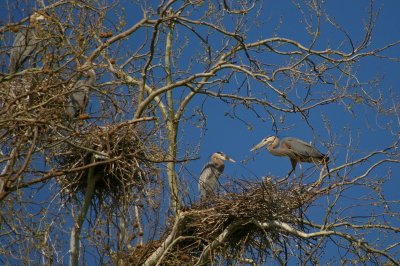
top-left (129, 181), bottom-right (317, 265)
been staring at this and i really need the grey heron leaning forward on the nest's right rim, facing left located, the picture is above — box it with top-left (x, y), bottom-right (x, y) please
top-left (251, 136), bottom-right (329, 176)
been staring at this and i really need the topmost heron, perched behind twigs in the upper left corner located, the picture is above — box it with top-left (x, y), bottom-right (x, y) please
top-left (9, 12), bottom-right (45, 73)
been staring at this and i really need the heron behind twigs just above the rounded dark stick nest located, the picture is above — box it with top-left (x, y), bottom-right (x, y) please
top-left (66, 69), bottom-right (96, 118)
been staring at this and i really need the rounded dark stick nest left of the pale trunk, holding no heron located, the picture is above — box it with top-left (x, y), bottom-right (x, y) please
top-left (56, 123), bottom-right (163, 204)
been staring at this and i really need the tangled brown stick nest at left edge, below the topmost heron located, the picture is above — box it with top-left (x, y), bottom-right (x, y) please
top-left (0, 73), bottom-right (89, 154)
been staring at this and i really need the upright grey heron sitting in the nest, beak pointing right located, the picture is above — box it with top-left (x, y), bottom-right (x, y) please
top-left (199, 152), bottom-right (235, 199)
